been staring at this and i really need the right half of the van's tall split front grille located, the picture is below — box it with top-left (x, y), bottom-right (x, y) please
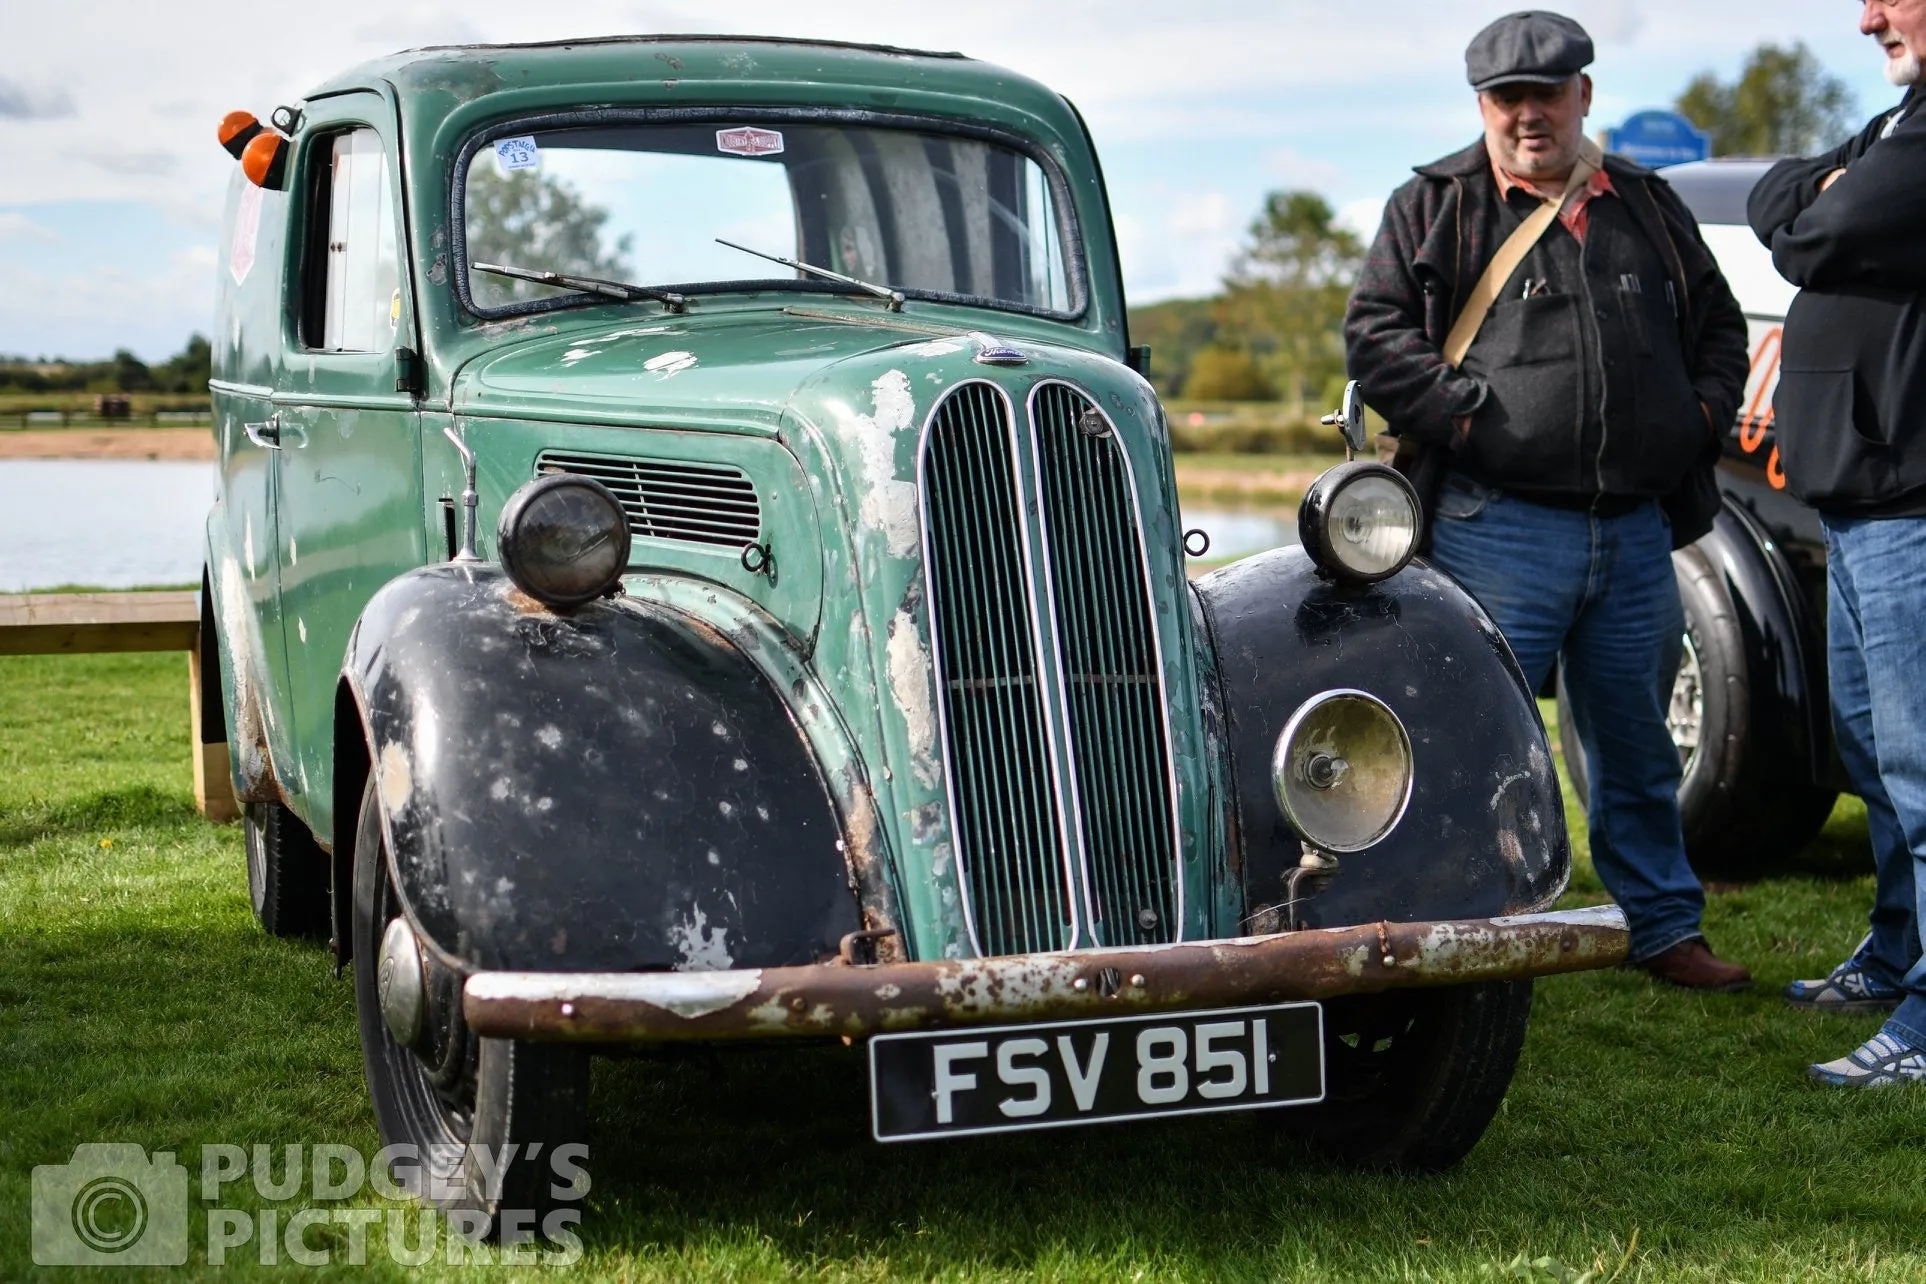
top-left (1030, 383), bottom-right (1183, 945)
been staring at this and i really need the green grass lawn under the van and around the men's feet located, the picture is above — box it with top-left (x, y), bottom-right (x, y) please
top-left (0, 655), bottom-right (1926, 1280)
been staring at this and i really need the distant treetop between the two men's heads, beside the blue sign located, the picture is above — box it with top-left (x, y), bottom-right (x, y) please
top-left (1678, 42), bottom-right (1859, 156)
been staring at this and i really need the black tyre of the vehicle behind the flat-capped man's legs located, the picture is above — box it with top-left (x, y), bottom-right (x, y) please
top-left (1558, 545), bottom-right (1839, 878)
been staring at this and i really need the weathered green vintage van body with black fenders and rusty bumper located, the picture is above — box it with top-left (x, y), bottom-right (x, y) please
top-left (206, 37), bottom-right (1624, 1136)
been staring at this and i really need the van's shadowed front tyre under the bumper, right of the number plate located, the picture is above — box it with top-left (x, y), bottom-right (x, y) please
top-left (1283, 980), bottom-right (1531, 1172)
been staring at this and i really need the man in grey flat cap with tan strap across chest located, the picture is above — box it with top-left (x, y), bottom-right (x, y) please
top-left (1344, 10), bottom-right (1751, 991)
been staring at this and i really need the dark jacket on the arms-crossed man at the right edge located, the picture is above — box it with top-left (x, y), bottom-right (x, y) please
top-left (1747, 90), bottom-right (1926, 516)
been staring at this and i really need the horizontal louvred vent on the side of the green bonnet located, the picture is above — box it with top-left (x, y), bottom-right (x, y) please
top-left (535, 450), bottom-right (763, 549)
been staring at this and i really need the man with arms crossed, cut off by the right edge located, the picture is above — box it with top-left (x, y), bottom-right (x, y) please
top-left (1747, 0), bottom-right (1926, 1086)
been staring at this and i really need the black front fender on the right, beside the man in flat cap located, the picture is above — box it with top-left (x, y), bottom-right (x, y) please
top-left (1194, 549), bottom-right (1572, 928)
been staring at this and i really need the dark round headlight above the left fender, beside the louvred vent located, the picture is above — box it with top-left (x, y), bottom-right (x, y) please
top-left (495, 474), bottom-right (628, 606)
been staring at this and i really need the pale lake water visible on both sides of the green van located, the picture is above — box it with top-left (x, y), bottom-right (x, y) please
top-left (0, 460), bottom-right (1298, 593)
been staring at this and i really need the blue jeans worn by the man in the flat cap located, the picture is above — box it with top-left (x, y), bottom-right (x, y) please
top-left (1431, 475), bottom-right (1705, 963)
